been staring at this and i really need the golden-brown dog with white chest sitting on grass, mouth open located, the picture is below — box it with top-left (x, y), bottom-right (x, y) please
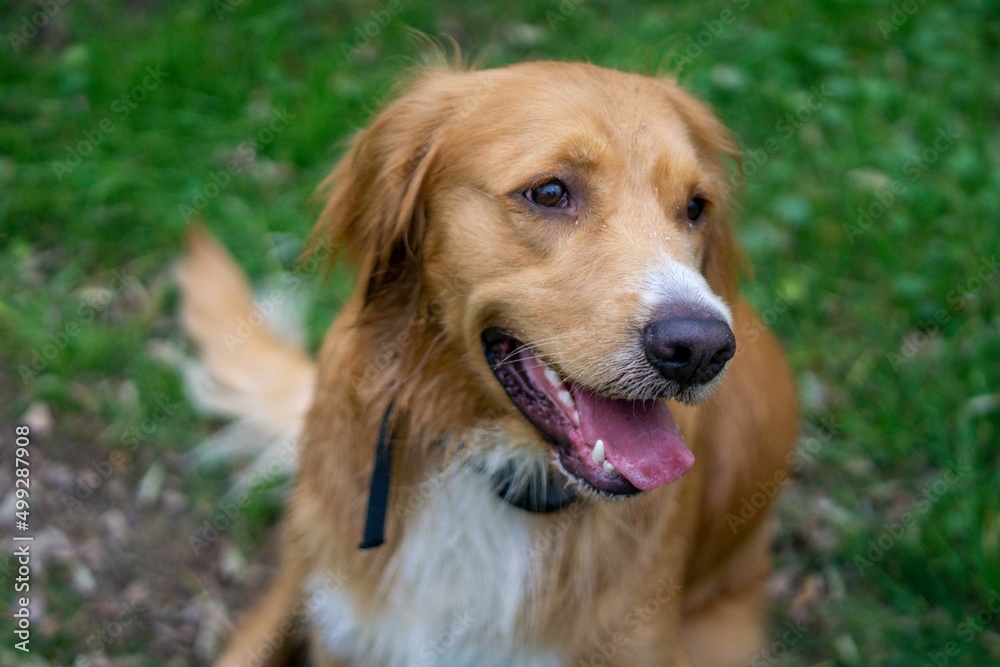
top-left (181, 62), bottom-right (799, 667)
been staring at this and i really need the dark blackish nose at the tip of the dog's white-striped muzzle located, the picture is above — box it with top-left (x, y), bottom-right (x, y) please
top-left (645, 317), bottom-right (736, 388)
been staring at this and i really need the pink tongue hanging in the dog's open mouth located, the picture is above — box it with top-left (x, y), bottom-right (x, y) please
top-left (573, 387), bottom-right (694, 491)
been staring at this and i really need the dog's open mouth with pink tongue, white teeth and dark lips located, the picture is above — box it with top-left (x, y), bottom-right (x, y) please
top-left (482, 328), bottom-right (694, 496)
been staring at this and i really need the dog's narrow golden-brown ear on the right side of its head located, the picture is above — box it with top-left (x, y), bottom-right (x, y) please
top-left (669, 82), bottom-right (747, 303)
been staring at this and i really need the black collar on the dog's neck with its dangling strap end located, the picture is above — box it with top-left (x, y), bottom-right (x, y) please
top-left (359, 403), bottom-right (577, 549)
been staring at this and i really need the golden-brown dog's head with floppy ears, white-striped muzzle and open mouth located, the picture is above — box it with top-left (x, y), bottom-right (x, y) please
top-left (316, 63), bottom-right (737, 495)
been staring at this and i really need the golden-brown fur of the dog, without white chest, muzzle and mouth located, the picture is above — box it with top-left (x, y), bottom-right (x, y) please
top-left (182, 63), bottom-right (798, 666)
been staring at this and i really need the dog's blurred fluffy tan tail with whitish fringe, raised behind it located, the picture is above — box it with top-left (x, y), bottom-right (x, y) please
top-left (178, 227), bottom-right (316, 487)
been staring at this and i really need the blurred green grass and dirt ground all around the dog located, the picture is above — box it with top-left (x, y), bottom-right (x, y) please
top-left (0, 0), bottom-right (1000, 666)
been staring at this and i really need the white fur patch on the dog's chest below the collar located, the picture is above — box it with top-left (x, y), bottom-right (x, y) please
top-left (307, 469), bottom-right (562, 667)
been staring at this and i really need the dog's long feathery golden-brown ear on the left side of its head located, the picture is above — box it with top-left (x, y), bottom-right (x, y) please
top-left (310, 70), bottom-right (464, 303)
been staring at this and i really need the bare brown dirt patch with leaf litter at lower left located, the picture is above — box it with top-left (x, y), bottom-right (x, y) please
top-left (0, 400), bottom-right (276, 667)
